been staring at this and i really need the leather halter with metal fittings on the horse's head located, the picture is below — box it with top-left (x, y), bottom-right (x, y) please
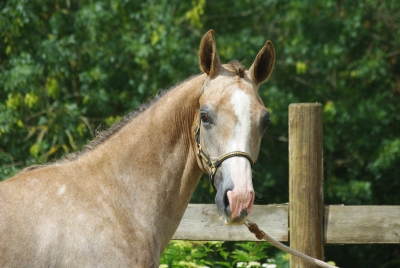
top-left (194, 119), bottom-right (254, 192)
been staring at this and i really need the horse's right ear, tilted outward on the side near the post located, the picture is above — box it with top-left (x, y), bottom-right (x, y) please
top-left (249, 40), bottom-right (275, 85)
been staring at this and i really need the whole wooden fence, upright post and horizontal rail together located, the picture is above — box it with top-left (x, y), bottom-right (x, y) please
top-left (173, 103), bottom-right (400, 268)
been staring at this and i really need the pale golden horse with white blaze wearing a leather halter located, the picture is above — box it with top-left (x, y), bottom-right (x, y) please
top-left (0, 30), bottom-right (275, 267)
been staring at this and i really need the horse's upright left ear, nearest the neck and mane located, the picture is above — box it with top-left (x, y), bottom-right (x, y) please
top-left (199, 30), bottom-right (221, 77)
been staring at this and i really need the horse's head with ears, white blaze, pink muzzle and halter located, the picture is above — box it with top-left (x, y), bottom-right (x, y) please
top-left (195, 30), bottom-right (275, 224)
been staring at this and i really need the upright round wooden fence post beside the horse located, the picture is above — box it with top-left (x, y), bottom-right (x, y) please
top-left (289, 103), bottom-right (324, 268)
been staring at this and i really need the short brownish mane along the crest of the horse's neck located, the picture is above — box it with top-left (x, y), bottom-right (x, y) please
top-left (21, 74), bottom-right (202, 173)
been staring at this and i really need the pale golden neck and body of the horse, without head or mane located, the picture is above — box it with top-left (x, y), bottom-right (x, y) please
top-left (0, 75), bottom-right (204, 267)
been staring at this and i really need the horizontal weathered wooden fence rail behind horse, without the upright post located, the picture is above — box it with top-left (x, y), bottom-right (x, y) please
top-left (172, 204), bottom-right (400, 244)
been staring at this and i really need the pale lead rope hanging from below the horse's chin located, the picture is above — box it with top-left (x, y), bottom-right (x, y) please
top-left (244, 220), bottom-right (339, 268)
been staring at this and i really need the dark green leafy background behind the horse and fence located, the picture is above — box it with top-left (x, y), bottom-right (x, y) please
top-left (0, 0), bottom-right (400, 267)
